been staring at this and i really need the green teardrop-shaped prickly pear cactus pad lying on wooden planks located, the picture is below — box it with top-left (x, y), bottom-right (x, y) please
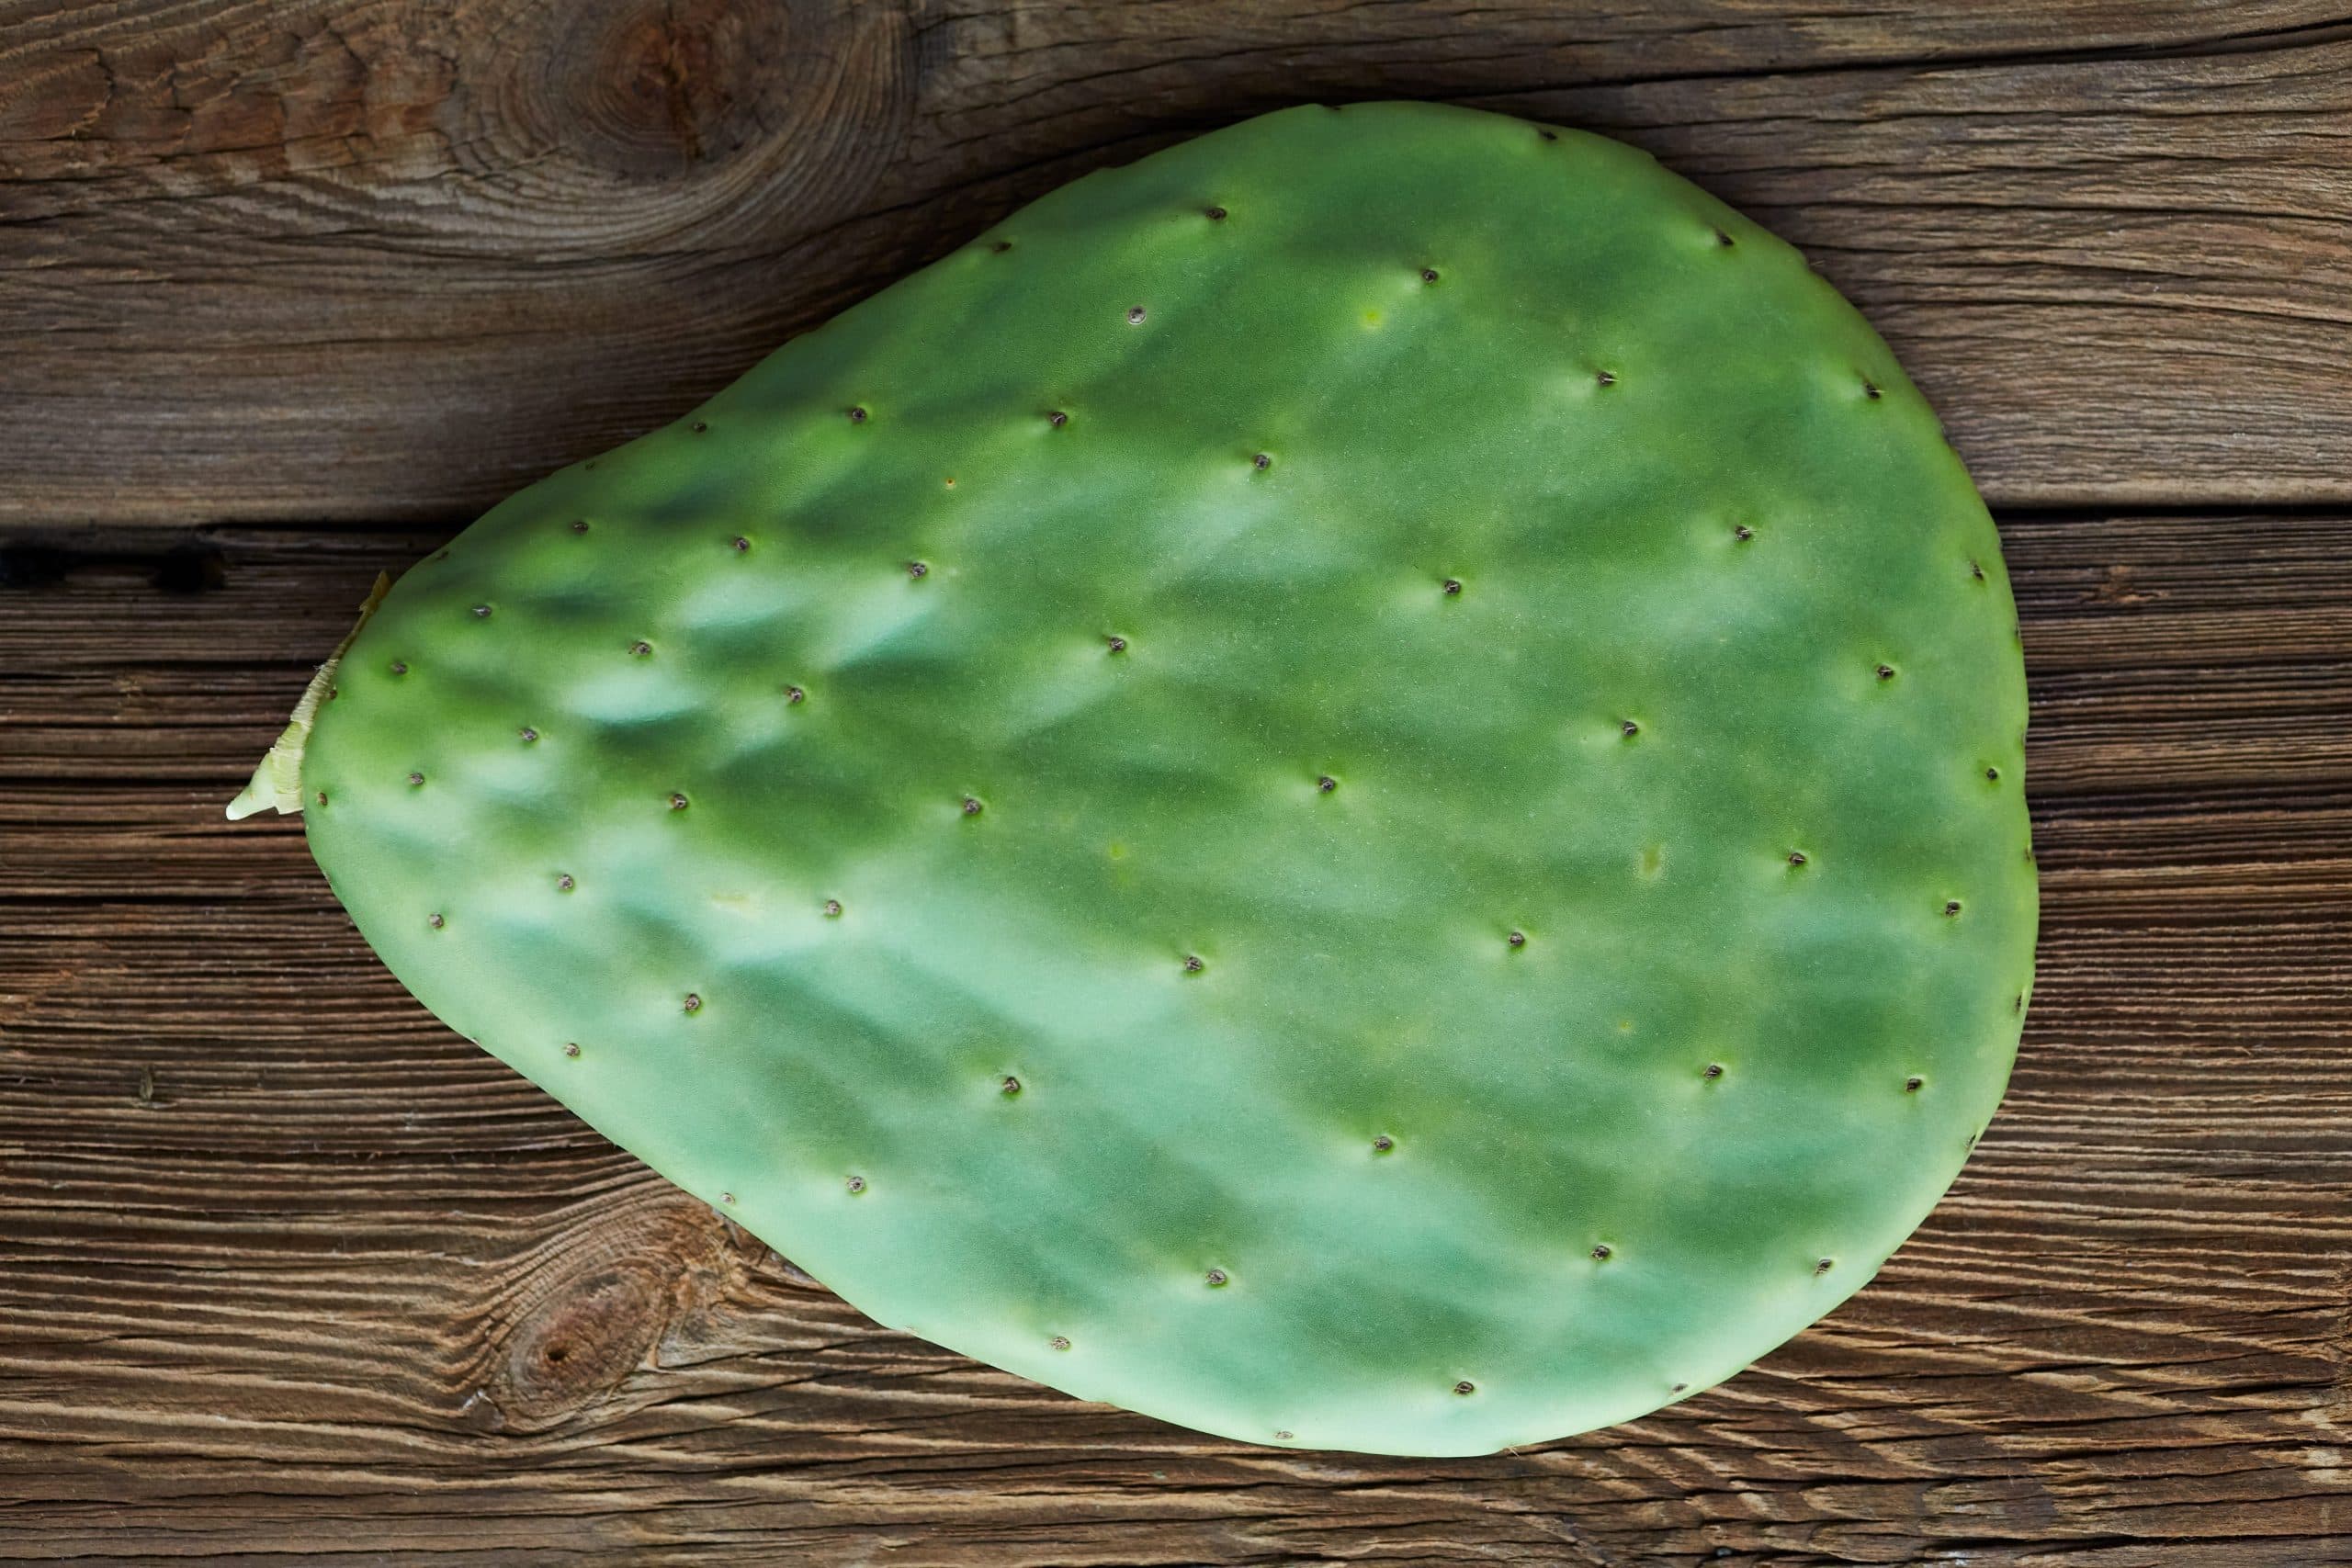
top-left (257, 104), bottom-right (2034, 1453)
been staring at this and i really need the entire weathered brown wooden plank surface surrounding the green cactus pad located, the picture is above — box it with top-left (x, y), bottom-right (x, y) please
top-left (0, 0), bottom-right (2352, 1568)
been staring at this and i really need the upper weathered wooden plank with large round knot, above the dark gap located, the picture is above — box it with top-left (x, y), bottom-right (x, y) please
top-left (0, 0), bottom-right (2352, 525)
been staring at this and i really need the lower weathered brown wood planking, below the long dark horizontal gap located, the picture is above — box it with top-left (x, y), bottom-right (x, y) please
top-left (0, 510), bottom-right (2352, 1568)
